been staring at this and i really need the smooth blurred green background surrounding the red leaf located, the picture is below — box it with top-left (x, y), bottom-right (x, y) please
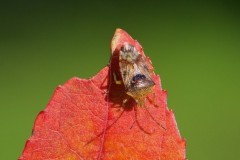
top-left (0, 0), bottom-right (240, 160)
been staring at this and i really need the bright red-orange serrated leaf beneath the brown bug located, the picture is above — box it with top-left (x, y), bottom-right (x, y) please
top-left (19, 29), bottom-right (185, 160)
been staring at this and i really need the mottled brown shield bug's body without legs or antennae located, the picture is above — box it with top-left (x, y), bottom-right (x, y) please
top-left (119, 43), bottom-right (155, 106)
